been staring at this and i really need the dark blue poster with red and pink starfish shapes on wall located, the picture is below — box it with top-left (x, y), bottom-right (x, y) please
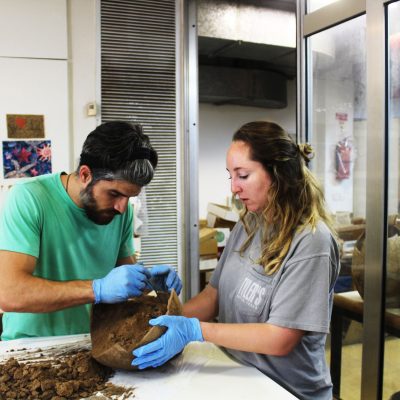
top-left (3, 140), bottom-right (51, 179)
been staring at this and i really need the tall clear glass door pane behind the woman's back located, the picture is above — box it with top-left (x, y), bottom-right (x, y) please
top-left (308, 15), bottom-right (367, 400)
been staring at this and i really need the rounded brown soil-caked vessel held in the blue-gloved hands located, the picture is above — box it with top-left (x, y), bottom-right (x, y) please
top-left (90, 290), bottom-right (182, 370)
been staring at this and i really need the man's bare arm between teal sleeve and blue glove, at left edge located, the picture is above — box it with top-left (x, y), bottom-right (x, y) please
top-left (0, 250), bottom-right (94, 312)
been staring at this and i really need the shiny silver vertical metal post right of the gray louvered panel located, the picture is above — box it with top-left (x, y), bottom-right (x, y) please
top-left (183, 0), bottom-right (200, 299)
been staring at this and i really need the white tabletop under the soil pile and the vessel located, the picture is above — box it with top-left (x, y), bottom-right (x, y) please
top-left (0, 335), bottom-right (296, 400)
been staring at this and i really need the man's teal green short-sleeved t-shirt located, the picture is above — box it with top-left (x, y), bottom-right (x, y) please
top-left (0, 173), bottom-right (134, 340)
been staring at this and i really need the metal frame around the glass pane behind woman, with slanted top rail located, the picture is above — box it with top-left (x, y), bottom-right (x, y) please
top-left (297, 0), bottom-right (390, 400)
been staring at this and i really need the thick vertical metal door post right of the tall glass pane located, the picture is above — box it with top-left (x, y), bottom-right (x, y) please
top-left (361, 0), bottom-right (387, 400)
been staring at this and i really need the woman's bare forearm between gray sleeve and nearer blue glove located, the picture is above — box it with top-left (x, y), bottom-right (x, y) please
top-left (200, 322), bottom-right (304, 356)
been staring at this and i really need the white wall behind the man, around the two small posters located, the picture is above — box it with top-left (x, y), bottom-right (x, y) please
top-left (0, 0), bottom-right (96, 207)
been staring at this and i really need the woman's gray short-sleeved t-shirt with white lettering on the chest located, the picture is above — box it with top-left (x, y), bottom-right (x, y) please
top-left (210, 222), bottom-right (340, 400)
